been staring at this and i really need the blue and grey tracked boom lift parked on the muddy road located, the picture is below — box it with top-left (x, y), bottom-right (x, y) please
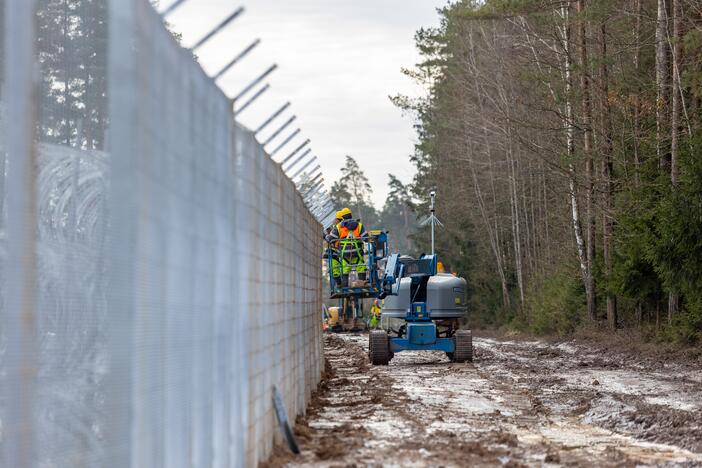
top-left (325, 193), bottom-right (473, 365)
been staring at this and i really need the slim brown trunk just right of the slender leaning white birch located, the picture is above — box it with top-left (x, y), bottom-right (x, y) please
top-left (577, 0), bottom-right (597, 320)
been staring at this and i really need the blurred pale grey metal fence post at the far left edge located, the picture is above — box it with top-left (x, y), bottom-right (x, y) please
top-left (0, 0), bottom-right (37, 467)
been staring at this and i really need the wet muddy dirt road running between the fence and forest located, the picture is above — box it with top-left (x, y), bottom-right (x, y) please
top-left (272, 336), bottom-right (702, 466)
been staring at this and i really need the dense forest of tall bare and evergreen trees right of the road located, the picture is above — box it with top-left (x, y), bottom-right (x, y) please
top-left (382, 0), bottom-right (702, 344)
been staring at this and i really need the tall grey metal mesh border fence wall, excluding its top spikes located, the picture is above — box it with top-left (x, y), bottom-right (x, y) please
top-left (0, 0), bottom-right (323, 468)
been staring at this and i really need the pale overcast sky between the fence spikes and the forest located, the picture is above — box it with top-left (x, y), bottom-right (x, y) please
top-left (166, 0), bottom-right (446, 208)
